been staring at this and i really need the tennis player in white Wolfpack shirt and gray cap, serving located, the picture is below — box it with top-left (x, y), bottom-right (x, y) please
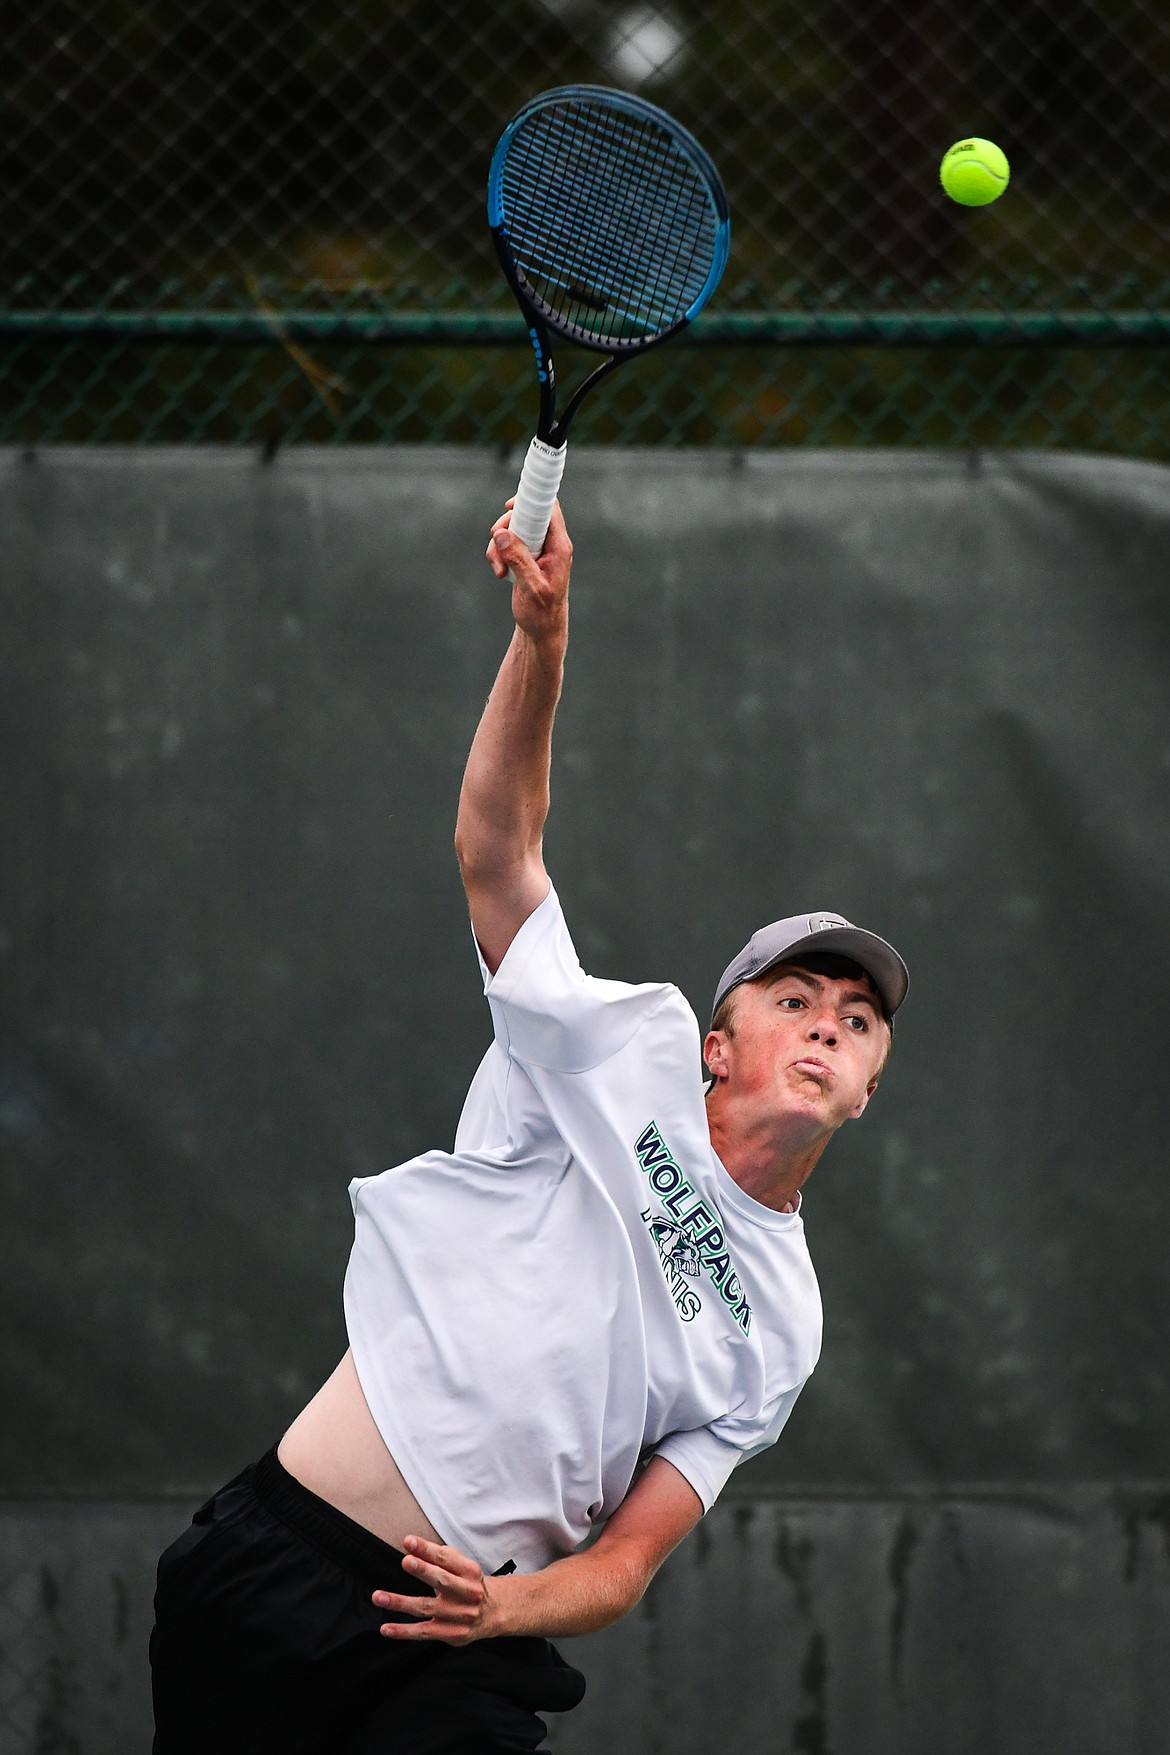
top-left (151, 509), bottom-right (907, 1755)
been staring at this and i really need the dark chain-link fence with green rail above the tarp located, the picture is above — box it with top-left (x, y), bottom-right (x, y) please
top-left (0, 0), bottom-right (1170, 456)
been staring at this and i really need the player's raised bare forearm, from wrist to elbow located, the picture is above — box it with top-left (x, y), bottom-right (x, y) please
top-left (454, 627), bottom-right (567, 885)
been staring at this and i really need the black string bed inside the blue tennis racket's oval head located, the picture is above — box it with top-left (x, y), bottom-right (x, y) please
top-left (502, 102), bottom-right (719, 346)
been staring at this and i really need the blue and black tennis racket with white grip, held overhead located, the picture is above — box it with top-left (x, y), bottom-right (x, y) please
top-left (488, 86), bottom-right (731, 555)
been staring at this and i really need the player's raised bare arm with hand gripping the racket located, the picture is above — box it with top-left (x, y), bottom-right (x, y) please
top-left (454, 505), bottom-right (574, 972)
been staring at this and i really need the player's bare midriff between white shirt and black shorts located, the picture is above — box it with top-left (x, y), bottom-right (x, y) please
top-left (277, 1353), bottom-right (442, 1548)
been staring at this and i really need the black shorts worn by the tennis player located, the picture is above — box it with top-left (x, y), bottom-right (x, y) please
top-left (151, 1450), bottom-right (584, 1755)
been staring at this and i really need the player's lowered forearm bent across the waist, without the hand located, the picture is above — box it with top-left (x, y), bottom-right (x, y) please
top-left (488, 1548), bottom-right (653, 1639)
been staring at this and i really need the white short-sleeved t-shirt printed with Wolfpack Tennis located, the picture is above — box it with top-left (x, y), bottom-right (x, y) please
top-left (346, 890), bottom-right (821, 1572)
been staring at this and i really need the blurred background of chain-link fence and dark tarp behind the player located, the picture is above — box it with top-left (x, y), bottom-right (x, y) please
top-left (0, 0), bottom-right (1170, 1755)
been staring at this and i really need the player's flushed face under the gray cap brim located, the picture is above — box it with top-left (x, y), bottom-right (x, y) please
top-left (724, 967), bottom-right (889, 1130)
